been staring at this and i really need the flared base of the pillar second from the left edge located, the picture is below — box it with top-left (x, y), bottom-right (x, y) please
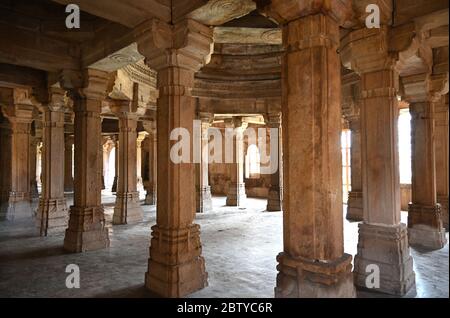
top-left (36, 198), bottom-right (69, 236)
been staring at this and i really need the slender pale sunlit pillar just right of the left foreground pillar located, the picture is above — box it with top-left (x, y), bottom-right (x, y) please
top-left (197, 113), bottom-right (214, 213)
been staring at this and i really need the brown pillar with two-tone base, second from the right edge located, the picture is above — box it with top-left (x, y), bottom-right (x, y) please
top-left (402, 74), bottom-right (447, 250)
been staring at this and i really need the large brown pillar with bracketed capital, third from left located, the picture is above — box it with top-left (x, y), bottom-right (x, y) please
top-left (63, 69), bottom-right (109, 253)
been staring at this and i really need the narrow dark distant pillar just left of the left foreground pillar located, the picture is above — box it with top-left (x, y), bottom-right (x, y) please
top-left (144, 121), bottom-right (158, 205)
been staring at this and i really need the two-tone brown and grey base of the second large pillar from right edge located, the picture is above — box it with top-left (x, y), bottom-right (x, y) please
top-left (408, 204), bottom-right (447, 250)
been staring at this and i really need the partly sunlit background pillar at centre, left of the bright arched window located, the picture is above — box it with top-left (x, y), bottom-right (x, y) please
top-left (225, 117), bottom-right (248, 206)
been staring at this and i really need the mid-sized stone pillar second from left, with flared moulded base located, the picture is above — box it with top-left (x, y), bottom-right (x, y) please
top-left (36, 88), bottom-right (69, 236)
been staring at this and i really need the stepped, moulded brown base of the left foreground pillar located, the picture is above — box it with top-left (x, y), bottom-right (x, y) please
top-left (145, 224), bottom-right (208, 298)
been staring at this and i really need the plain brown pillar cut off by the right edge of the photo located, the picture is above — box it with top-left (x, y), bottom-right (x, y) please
top-left (435, 94), bottom-right (449, 230)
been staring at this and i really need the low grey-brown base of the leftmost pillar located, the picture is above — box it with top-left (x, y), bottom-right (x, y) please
top-left (0, 194), bottom-right (35, 222)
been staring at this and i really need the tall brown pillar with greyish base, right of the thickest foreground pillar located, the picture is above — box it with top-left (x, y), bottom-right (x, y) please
top-left (341, 26), bottom-right (415, 295)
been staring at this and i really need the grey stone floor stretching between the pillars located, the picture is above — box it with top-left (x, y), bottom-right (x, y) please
top-left (0, 193), bottom-right (449, 298)
